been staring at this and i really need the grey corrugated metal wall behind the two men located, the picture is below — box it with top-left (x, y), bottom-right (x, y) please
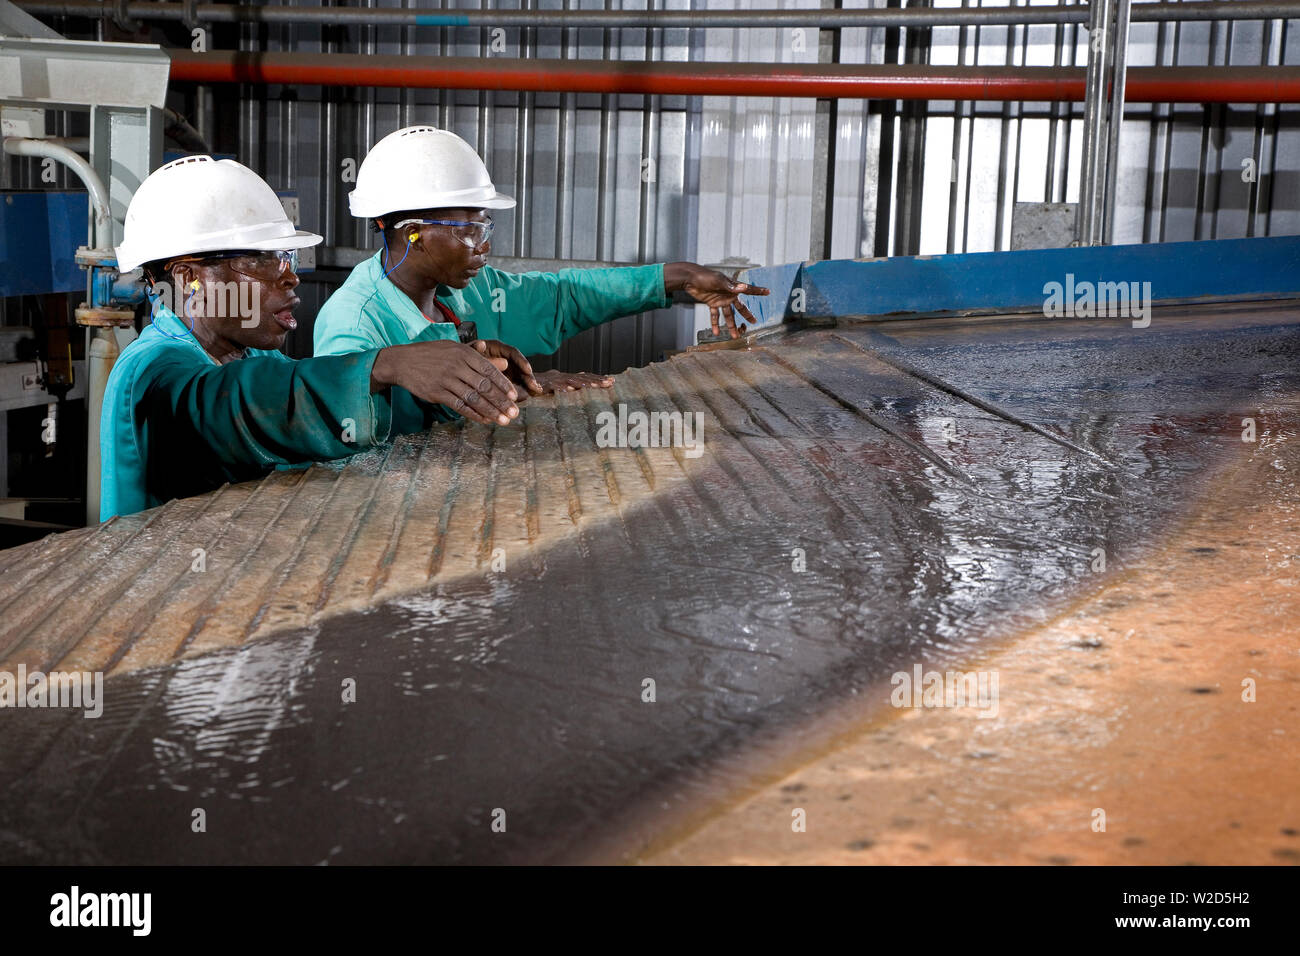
top-left (14, 0), bottom-right (1300, 369)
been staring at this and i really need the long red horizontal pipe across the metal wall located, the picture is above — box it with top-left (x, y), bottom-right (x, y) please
top-left (168, 49), bottom-right (1300, 103)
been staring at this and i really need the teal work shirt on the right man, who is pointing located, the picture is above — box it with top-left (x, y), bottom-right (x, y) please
top-left (315, 252), bottom-right (671, 434)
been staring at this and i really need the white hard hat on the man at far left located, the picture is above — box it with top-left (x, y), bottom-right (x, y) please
top-left (117, 156), bottom-right (321, 272)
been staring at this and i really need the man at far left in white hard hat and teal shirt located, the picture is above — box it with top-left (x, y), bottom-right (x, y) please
top-left (100, 156), bottom-right (541, 520)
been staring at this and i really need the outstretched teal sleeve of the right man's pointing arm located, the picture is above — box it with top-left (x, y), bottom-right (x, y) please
top-left (484, 264), bottom-right (672, 355)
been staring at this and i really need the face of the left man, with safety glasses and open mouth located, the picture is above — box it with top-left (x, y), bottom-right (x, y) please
top-left (172, 260), bottom-right (302, 362)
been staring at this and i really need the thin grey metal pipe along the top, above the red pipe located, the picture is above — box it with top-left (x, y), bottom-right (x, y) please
top-left (18, 0), bottom-right (1300, 30)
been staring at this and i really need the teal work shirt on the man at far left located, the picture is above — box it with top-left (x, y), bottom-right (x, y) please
top-left (99, 308), bottom-right (391, 520)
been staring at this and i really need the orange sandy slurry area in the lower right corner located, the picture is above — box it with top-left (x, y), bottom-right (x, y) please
top-left (641, 436), bottom-right (1300, 864)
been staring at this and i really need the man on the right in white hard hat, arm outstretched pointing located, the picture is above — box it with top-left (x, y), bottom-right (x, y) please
top-left (315, 126), bottom-right (767, 432)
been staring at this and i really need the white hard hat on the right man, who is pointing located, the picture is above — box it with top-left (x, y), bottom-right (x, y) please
top-left (347, 126), bottom-right (515, 219)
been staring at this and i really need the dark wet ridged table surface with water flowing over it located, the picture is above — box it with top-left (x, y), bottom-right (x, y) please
top-left (0, 304), bottom-right (1300, 864)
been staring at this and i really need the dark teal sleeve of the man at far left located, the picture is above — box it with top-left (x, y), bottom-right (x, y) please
top-left (143, 350), bottom-right (391, 467)
